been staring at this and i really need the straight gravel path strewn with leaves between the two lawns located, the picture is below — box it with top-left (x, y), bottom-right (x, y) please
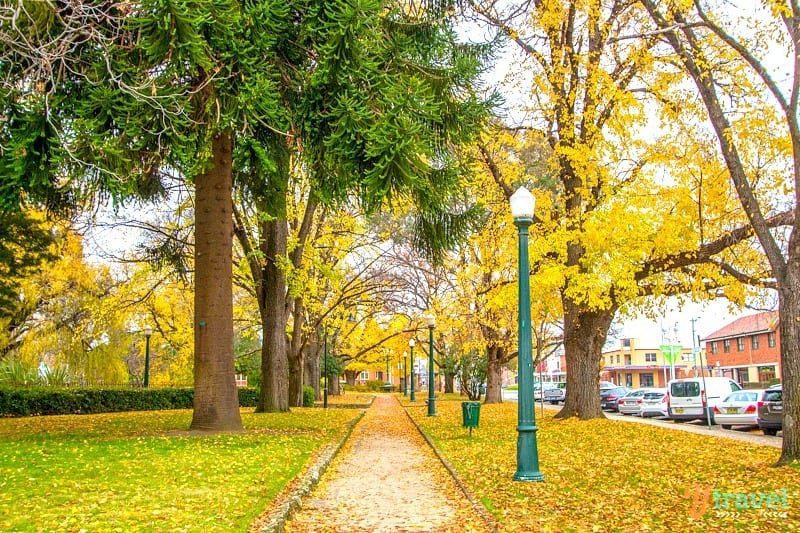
top-left (286, 396), bottom-right (485, 532)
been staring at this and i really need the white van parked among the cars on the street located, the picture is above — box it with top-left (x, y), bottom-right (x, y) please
top-left (667, 377), bottom-right (741, 424)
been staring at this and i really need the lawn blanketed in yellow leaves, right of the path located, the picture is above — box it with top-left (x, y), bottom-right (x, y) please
top-left (407, 401), bottom-right (800, 531)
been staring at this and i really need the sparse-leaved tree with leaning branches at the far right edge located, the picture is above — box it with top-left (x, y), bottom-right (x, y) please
top-left (642, 0), bottom-right (800, 464)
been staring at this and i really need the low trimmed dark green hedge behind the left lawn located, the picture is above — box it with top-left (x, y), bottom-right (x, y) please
top-left (0, 388), bottom-right (258, 417)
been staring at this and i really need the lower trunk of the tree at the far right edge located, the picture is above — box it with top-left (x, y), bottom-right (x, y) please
top-left (778, 268), bottom-right (800, 465)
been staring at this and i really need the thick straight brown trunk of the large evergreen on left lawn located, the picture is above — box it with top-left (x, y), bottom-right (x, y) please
top-left (191, 131), bottom-right (242, 431)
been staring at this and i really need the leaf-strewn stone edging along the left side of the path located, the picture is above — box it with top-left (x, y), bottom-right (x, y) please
top-left (248, 404), bottom-right (371, 533)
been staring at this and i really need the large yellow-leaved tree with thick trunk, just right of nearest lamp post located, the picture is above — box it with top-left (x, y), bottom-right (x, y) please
top-left (470, 0), bottom-right (787, 419)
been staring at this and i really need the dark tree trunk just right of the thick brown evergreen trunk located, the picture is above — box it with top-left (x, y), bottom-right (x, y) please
top-left (256, 208), bottom-right (289, 413)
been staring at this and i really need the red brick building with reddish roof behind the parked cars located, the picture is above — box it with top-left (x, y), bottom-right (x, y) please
top-left (703, 311), bottom-right (781, 385)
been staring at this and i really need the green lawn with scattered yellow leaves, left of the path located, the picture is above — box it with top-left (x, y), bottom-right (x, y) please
top-left (0, 409), bottom-right (358, 531)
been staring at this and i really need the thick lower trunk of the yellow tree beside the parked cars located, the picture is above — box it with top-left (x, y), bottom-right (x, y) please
top-left (556, 298), bottom-right (616, 420)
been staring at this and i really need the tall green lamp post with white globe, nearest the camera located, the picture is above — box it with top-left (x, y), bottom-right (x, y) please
top-left (511, 187), bottom-right (544, 481)
